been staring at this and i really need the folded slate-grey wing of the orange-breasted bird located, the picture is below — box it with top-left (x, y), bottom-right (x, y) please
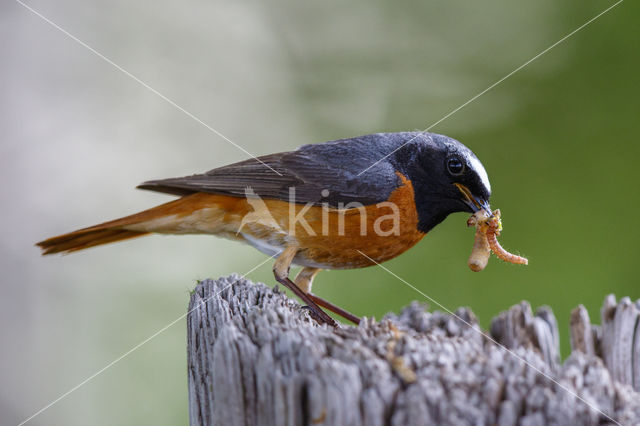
top-left (138, 133), bottom-right (412, 207)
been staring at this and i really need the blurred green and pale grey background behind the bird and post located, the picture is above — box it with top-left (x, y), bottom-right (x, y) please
top-left (0, 0), bottom-right (640, 425)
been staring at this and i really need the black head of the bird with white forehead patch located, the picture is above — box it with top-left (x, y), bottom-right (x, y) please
top-left (396, 133), bottom-right (491, 232)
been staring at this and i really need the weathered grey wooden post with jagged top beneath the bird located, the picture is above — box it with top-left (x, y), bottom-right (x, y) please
top-left (187, 276), bottom-right (640, 426)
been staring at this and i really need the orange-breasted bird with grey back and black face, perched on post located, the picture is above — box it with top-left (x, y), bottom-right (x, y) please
top-left (36, 132), bottom-right (491, 327)
